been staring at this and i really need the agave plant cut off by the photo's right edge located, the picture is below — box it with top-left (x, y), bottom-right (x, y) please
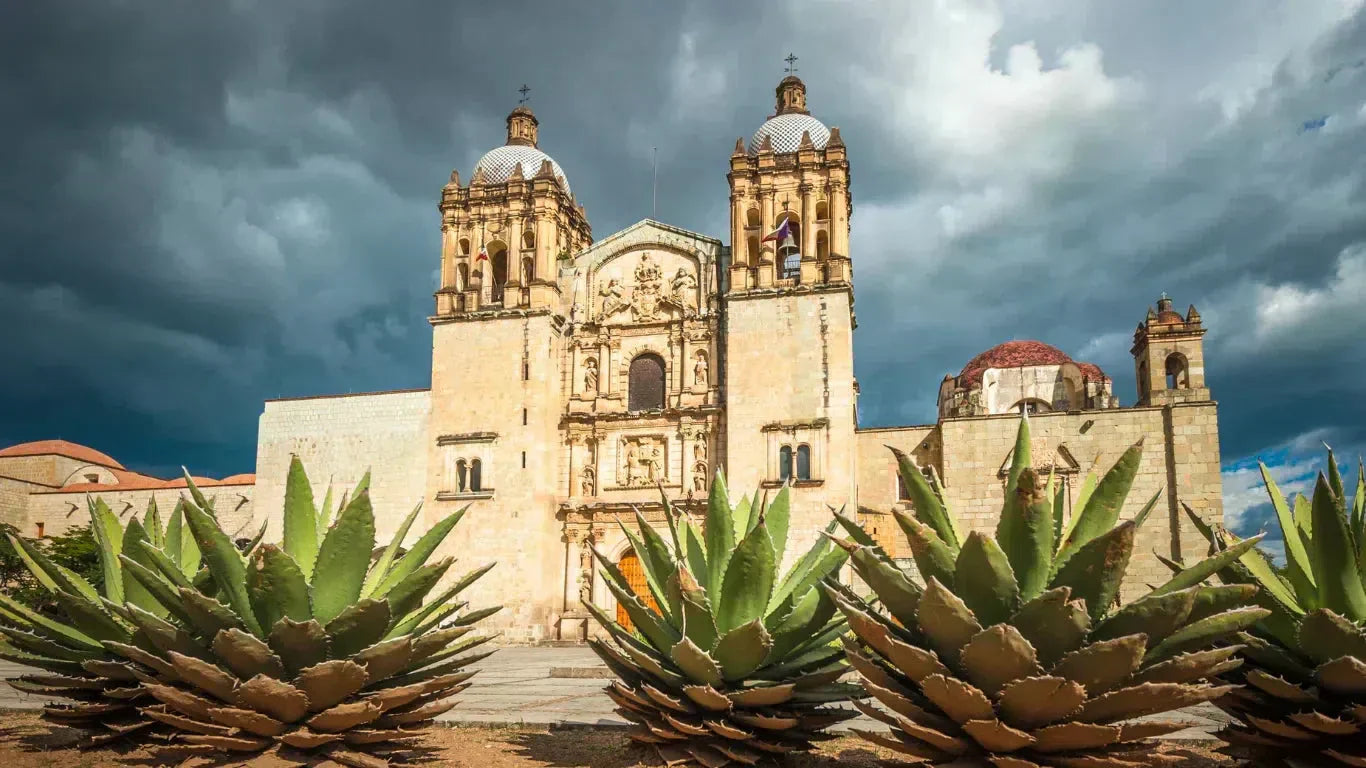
top-left (1169, 451), bottom-right (1366, 765)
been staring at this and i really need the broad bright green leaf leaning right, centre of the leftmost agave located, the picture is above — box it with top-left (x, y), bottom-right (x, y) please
top-left (313, 493), bottom-right (374, 625)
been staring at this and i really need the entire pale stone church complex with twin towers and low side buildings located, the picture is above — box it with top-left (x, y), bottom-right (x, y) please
top-left (0, 77), bottom-right (1223, 642)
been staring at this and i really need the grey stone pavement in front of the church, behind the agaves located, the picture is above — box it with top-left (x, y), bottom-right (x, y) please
top-left (0, 646), bottom-right (1228, 741)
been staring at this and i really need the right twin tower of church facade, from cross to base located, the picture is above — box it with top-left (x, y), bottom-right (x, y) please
top-left (724, 62), bottom-right (858, 565)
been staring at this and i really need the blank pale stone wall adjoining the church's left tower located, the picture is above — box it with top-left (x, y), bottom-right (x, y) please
top-left (254, 389), bottom-right (430, 543)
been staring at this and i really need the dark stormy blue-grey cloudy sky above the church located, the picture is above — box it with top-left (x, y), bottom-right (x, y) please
top-left (0, 0), bottom-right (1366, 533)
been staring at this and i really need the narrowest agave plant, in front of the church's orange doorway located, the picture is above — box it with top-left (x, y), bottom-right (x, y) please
top-left (585, 471), bottom-right (859, 768)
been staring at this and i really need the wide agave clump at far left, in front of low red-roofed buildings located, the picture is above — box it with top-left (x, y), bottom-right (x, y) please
top-left (5, 458), bottom-right (499, 767)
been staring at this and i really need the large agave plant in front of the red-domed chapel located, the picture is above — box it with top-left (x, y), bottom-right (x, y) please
top-left (826, 420), bottom-right (1268, 768)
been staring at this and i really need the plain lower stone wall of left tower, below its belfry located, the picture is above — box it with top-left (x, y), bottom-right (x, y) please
top-left (421, 312), bottom-right (566, 642)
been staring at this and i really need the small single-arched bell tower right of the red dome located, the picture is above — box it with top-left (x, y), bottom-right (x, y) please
top-left (1130, 294), bottom-right (1210, 406)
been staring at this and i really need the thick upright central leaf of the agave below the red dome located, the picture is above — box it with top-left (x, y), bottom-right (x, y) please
top-left (996, 464), bottom-right (1053, 600)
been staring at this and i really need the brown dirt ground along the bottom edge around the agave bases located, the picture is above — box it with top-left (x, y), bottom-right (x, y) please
top-left (0, 711), bottom-right (1238, 768)
